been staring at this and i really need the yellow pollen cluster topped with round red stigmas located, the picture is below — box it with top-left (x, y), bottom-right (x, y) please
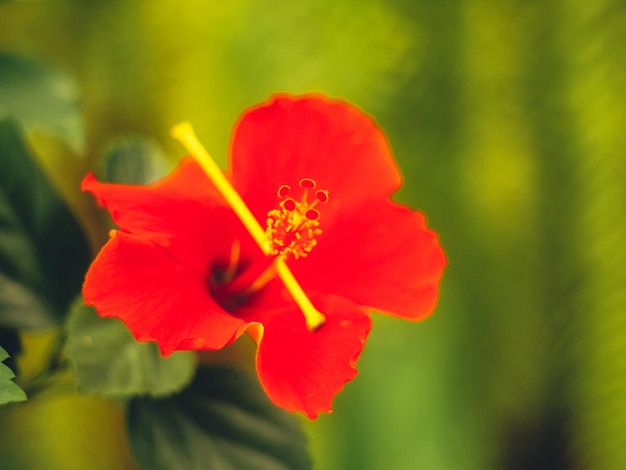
top-left (265, 178), bottom-right (328, 259)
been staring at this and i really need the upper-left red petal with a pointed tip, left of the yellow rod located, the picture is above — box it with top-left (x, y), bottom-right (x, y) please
top-left (82, 157), bottom-right (252, 270)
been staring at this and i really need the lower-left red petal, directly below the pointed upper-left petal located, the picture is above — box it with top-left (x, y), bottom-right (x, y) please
top-left (83, 232), bottom-right (246, 356)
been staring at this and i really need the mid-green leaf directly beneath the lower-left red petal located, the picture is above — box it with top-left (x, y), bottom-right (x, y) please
top-left (68, 299), bottom-right (196, 397)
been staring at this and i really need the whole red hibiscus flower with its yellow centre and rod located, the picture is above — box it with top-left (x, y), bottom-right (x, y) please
top-left (83, 95), bottom-right (446, 418)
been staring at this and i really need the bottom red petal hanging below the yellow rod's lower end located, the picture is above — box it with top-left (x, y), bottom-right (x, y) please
top-left (257, 296), bottom-right (371, 419)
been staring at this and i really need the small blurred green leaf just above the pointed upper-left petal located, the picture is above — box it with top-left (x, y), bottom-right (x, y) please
top-left (98, 136), bottom-right (170, 184)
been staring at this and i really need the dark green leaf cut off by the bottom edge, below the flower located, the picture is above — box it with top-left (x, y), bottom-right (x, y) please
top-left (128, 368), bottom-right (311, 470)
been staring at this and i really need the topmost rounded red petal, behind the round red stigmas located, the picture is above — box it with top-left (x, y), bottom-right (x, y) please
top-left (230, 95), bottom-right (402, 225)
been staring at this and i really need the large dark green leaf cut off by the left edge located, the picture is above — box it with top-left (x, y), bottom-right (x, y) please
top-left (0, 120), bottom-right (90, 329)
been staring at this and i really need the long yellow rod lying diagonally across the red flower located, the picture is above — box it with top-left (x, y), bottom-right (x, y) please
top-left (171, 122), bottom-right (326, 331)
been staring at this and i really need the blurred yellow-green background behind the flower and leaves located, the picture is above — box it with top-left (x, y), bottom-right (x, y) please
top-left (0, 0), bottom-right (626, 470)
